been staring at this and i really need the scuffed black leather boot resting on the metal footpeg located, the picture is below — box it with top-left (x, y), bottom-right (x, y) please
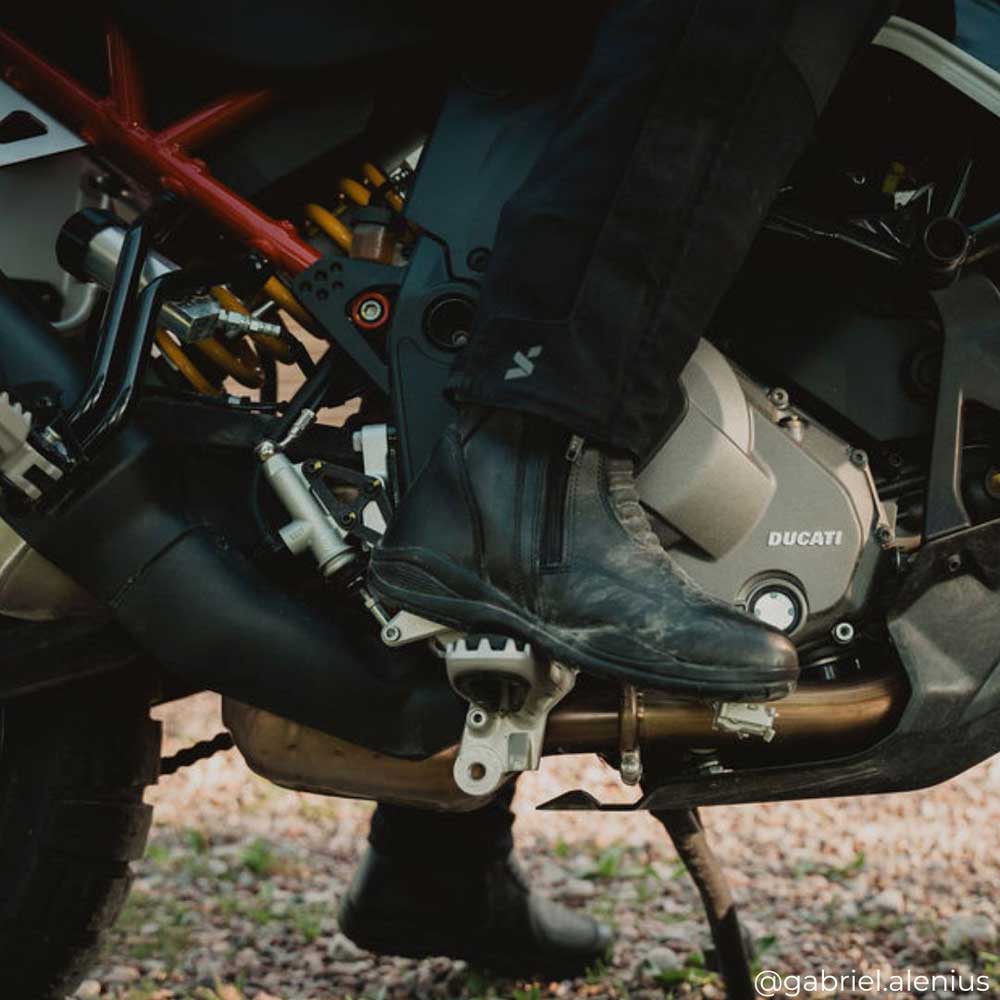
top-left (369, 409), bottom-right (798, 701)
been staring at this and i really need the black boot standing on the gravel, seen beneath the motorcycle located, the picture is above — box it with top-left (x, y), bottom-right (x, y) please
top-left (337, 844), bottom-right (613, 979)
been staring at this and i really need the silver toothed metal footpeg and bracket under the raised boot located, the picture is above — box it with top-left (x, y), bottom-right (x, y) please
top-left (445, 636), bottom-right (577, 795)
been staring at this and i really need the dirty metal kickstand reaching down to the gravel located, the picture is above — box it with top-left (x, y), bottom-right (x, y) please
top-left (653, 809), bottom-right (757, 1000)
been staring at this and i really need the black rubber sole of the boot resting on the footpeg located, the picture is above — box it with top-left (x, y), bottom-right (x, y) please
top-left (368, 549), bottom-right (798, 702)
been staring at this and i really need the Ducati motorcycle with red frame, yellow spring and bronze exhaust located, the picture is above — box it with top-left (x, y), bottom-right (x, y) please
top-left (0, 3), bottom-right (1000, 996)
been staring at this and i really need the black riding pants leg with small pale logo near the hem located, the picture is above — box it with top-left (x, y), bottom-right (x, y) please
top-left (451, 0), bottom-right (891, 455)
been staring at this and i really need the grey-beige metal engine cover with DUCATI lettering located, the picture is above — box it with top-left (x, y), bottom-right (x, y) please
top-left (639, 341), bottom-right (881, 641)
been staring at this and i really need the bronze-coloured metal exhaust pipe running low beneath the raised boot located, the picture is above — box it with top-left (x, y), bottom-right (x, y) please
top-left (222, 674), bottom-right (907, 812)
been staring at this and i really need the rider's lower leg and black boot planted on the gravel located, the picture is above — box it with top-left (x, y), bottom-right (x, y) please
top-left (339, 784), bottom-right (611, 978)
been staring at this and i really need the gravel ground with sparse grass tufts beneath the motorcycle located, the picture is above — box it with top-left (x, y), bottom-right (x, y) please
top-left (76, 695), bottom-right (1000, 1000)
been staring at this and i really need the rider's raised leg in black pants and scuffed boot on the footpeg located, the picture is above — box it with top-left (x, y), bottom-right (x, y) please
top-left (371, 0), bottom-right (896, 700)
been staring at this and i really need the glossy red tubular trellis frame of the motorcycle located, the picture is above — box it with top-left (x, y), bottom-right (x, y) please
top-left (0, 24), bottom-right (320, 274)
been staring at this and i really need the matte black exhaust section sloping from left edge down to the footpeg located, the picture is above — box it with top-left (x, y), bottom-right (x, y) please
top-left (0, 274), bottom-right (465, 758)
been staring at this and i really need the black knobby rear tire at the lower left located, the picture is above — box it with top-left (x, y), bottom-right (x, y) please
top-left (0, 671), bottom-right (160, 1000)
